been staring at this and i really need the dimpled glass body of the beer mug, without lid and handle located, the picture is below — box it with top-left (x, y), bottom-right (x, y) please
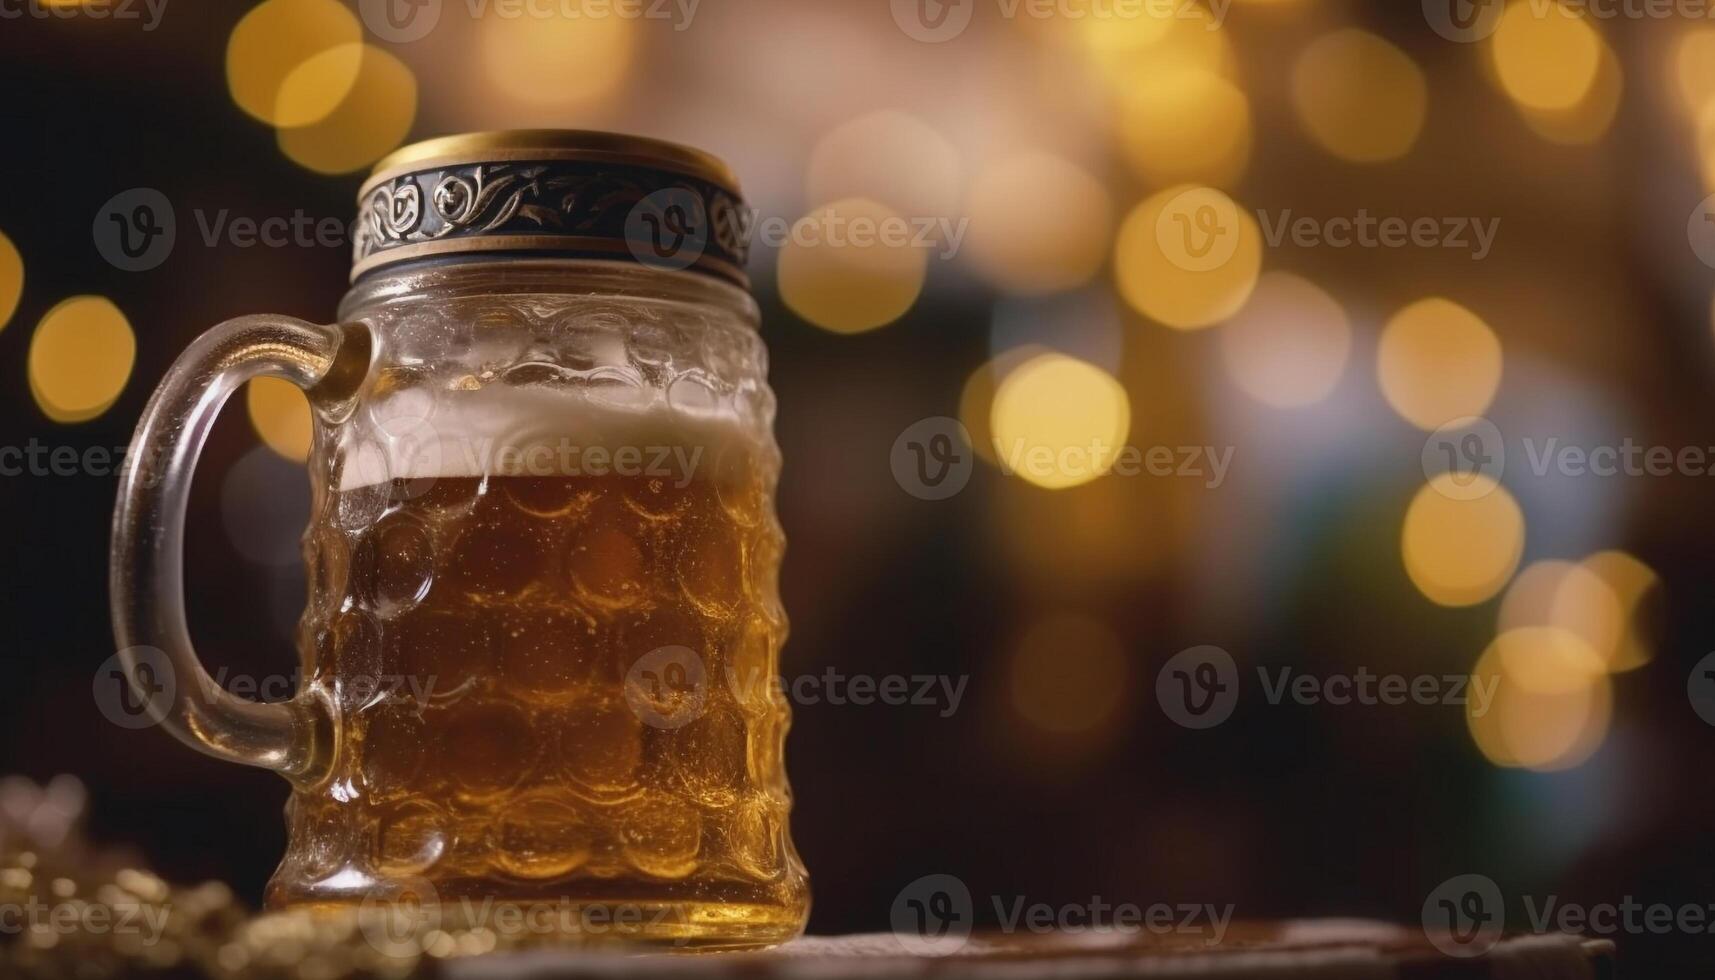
top-left (268, 261), bottom-right (809, 947)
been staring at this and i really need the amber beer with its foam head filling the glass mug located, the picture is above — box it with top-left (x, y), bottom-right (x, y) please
top-left (282, 391), bottom-right (803, 920)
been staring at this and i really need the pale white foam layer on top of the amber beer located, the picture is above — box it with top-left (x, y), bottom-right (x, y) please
top-left (338, 384), bottom-right (765, 491)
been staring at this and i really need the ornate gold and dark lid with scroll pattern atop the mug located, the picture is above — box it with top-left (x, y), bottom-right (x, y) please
top-left (352, 129), bottom-right (751, 287)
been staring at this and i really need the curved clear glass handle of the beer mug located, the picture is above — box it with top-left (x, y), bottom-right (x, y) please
top-left (108, 316), bottom-right (369, 781)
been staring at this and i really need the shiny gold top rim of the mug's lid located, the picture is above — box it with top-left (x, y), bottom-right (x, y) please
top-left (358, 129), bottom-right (743, 199)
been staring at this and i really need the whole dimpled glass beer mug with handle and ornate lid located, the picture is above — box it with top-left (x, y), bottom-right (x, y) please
top-left (111, 130), bottom-right (809, 947)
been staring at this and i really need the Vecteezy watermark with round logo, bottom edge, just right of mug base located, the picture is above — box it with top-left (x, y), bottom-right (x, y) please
top-left (888, 874), bottom-right (1233, 956)
